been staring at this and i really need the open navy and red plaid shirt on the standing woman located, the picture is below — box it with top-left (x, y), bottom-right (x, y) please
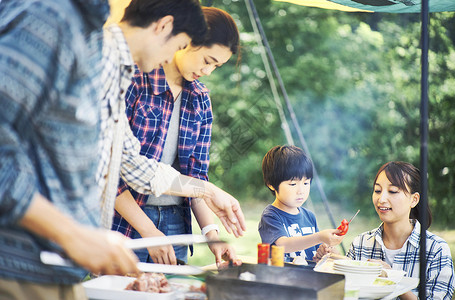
top-left (113, 68), bottom-right (213, 236)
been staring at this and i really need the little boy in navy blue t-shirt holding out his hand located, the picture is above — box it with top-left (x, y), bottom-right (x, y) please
top-left (259, 146), bottom-right (343, 262)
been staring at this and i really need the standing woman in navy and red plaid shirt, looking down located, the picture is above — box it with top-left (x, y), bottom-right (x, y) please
top-left (113, 7), bottom-right (239, 264)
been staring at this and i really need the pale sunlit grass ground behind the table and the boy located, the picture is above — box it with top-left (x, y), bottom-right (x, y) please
top-left (188, 201), bottom-right (455, 266)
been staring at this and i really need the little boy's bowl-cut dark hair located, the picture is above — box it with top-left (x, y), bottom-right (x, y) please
top-left (262, 145), bottom-right (313, 195)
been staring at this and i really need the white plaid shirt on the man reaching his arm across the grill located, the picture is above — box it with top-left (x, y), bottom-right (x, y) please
top-left (97, 24), bottom-right (179, 228)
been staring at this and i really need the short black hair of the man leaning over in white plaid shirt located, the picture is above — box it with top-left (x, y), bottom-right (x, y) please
top-left (122, 0), bottom-right (207, 43)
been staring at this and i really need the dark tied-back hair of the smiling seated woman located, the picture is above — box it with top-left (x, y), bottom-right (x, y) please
top-left (373, 161), bottom-right (432, 228)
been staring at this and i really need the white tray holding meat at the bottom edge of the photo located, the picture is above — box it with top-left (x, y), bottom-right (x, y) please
top-left (82, 275), bottom-right (181, 300)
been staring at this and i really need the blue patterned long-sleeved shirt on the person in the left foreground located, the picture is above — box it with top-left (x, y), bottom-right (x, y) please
top-left (0, 0), bottom-right (109, 284)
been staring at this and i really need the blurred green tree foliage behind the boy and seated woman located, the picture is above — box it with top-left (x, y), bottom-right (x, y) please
top-left (203, 0), bottom-right (455, 226)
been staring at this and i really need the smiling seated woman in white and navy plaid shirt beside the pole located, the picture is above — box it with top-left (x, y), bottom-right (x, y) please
top-left (347, 162), bottom-right (454, 299)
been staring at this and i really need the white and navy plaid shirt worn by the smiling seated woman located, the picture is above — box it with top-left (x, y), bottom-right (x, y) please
top-left (347, 220), bottom-right (454, 299)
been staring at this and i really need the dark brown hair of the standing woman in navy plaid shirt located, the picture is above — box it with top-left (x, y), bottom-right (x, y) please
top-left (191, 7), bottom-right (240, 54)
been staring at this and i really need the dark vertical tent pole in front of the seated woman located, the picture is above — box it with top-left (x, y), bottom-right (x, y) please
top-left (419, 0), bottom-right (429, 299)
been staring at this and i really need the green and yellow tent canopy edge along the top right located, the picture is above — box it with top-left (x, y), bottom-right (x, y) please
top-left (275, 0), bottom-right (455, 13)
